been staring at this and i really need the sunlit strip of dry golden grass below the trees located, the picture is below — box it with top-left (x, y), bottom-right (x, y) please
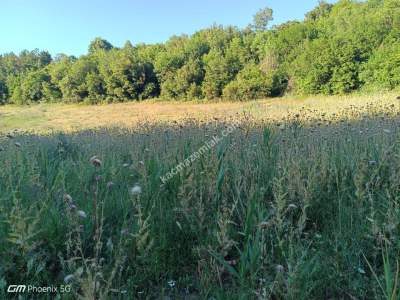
top-left (0, 93), bottom-right (400, 133)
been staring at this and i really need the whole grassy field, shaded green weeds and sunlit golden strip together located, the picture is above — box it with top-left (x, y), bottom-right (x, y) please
top-left (0, 94), bottom-right (400, 300)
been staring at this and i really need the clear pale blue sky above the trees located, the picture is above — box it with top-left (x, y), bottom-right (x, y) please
top-left (0, 0), bottom-right (333, 55)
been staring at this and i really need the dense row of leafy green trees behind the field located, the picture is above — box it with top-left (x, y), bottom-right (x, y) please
top-left (0, 0), bottom-right (400, 104)
